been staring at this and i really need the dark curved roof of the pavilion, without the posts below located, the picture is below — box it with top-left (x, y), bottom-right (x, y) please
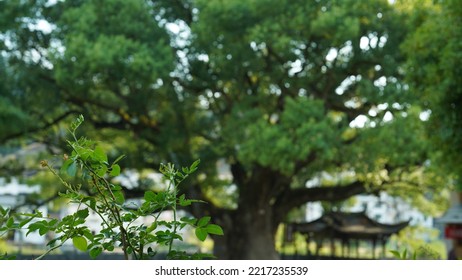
top-left (291, 212), bottom-right (409, 239)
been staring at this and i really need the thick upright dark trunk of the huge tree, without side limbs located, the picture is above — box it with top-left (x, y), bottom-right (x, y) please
top-left (210, 163), bottom-right (287, 260)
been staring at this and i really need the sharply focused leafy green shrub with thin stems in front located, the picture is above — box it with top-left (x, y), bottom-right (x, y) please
top-left (0, 116), bottom-right (223, 259)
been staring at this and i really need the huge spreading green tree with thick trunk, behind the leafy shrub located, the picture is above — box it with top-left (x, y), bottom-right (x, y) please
top-left (0, 0), bottom-right (443, 259)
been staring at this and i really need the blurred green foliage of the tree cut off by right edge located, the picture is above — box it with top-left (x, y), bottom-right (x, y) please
top-left (403, 0), bottom-right (462, 190)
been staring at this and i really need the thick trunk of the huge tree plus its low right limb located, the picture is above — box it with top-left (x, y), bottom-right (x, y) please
top-left (210, 164), bottom-right (365, 260)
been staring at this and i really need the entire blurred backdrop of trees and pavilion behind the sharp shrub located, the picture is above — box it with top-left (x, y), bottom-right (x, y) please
top-left (0, 0), bottom-right (462, 259)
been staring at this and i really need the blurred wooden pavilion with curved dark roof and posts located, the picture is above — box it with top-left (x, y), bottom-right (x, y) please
top-left (284, 212), bottom-right (409, 259)
